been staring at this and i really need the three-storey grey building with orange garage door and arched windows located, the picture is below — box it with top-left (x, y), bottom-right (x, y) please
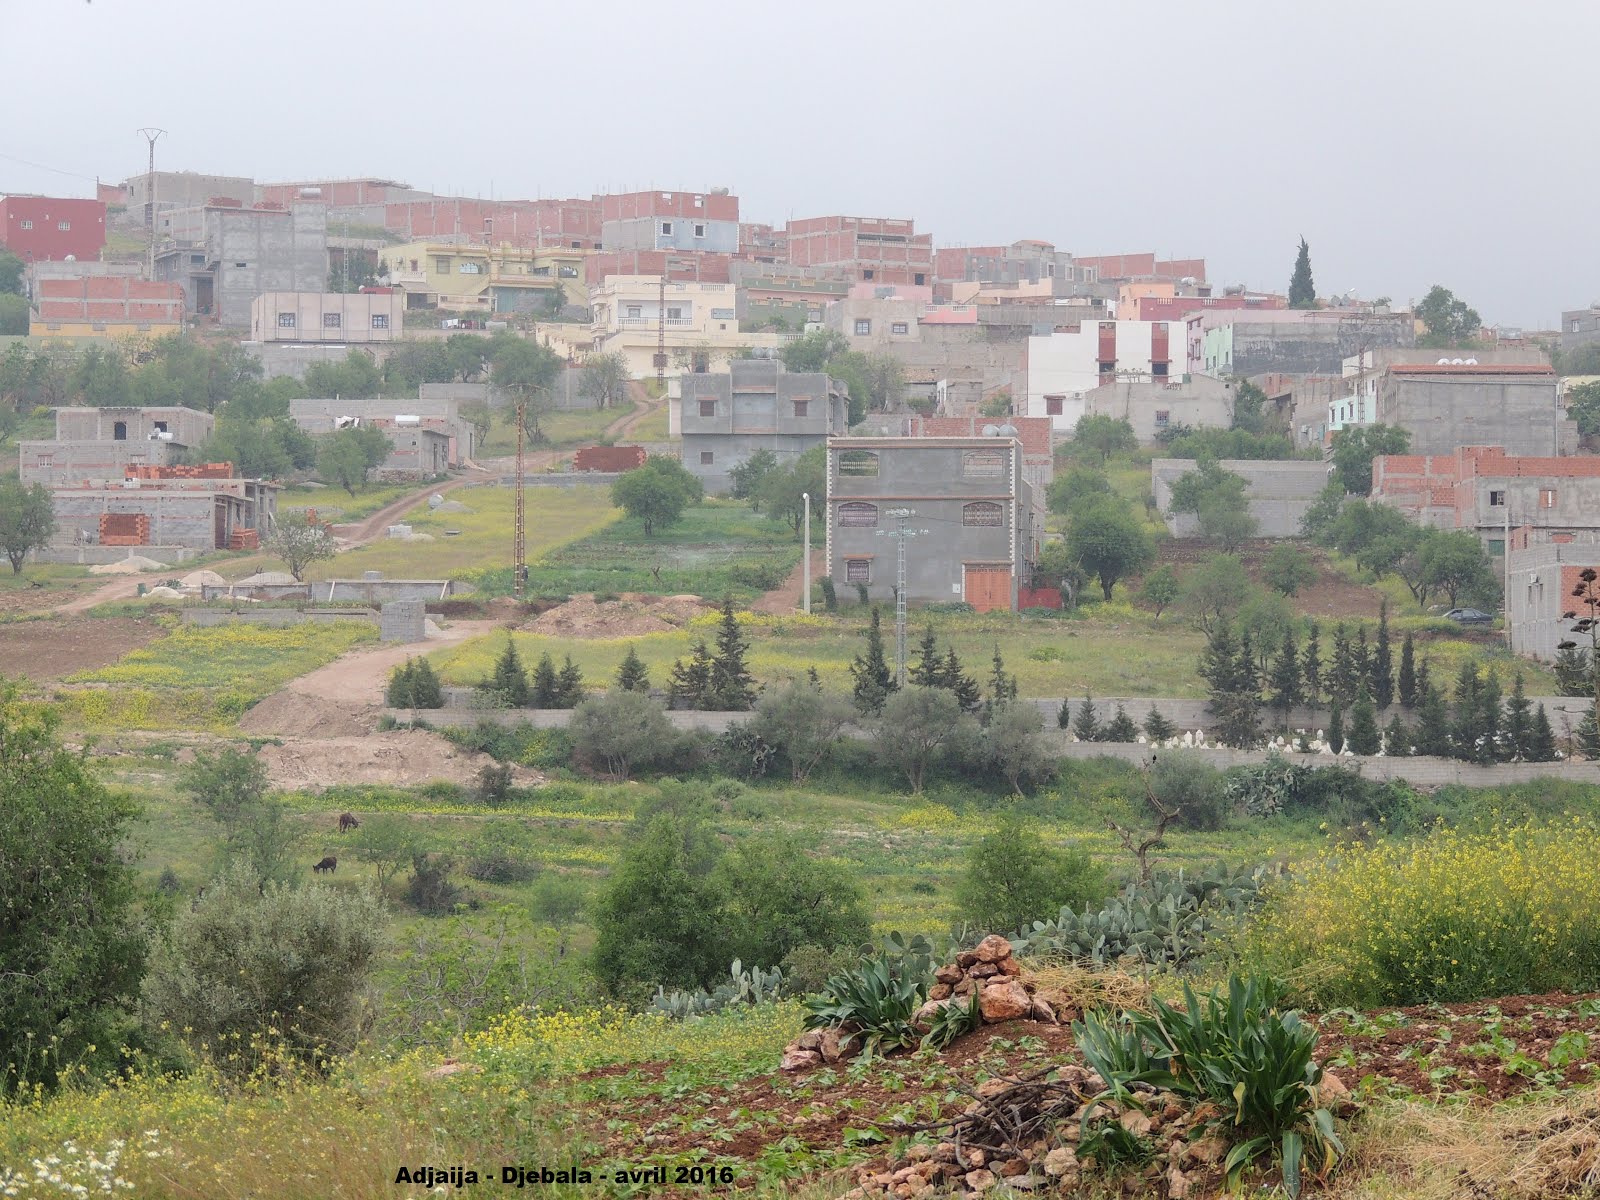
top-left (827, 437), bottom-right (1038, 611)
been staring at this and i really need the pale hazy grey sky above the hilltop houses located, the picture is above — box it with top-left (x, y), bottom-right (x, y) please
top-left (0, 0), bottom-right (1600, 326)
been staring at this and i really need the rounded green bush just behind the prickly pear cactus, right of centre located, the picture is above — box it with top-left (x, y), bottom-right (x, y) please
top-left (955, 814), bottom-right (1110, 933)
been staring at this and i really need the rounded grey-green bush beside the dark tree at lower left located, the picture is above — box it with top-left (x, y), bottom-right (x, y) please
top-left (144, 869), bottom-right (382, 1075)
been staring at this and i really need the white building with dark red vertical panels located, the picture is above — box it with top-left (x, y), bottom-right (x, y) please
top-left (1026, 322), bottom-right (1184, 430)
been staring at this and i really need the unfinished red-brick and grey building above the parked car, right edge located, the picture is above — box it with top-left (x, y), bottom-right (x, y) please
top-left (1373, 446), bottom-right (1600, 555)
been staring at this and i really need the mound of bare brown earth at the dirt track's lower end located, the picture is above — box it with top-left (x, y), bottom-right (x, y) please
top-left (261, 730), bottom-right (544, 789)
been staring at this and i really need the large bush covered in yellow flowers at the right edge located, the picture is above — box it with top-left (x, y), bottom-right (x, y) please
top-left (1240, 819), bottom-right (1600, 1008)
